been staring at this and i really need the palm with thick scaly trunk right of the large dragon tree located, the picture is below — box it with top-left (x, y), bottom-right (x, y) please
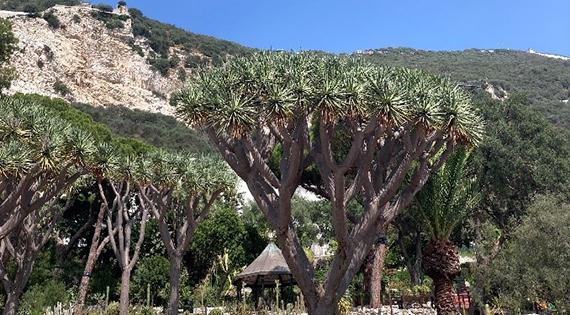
top-left (412, 148), bottom-right (478, 314)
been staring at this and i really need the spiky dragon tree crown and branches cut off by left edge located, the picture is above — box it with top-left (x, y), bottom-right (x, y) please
top-left (0, 98), bottom-right (94, 240)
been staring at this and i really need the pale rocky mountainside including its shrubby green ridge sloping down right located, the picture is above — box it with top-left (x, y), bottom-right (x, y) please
top-left (0, 2), bottom-right (249, 114)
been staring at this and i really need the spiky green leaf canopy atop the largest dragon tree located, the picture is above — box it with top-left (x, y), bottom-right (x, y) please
top-left (177, 52), bottom-right (483, 144)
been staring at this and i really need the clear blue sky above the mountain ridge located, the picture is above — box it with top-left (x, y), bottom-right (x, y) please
top-left (100, 0), bottom-right (570, 56)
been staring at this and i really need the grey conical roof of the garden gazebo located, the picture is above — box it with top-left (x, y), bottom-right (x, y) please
top-left (234, 243), bottom-right (295, 287)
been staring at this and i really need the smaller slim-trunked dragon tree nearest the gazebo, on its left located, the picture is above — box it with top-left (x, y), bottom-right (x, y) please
top-left (138, 152), bottom-right (235, 314)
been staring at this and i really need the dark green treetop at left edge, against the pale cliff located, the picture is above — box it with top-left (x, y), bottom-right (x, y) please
top-left (0, 18), bottom-right (18, 94)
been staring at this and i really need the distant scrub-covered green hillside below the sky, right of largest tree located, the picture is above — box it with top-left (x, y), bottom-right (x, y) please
top-left (363, 48), bottom-right (570, 127)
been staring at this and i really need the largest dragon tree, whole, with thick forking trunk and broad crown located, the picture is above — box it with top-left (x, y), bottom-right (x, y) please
top-left (178, 53), bottom-right (482, 315)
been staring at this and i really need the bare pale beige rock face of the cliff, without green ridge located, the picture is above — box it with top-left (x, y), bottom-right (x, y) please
top-left (9, 6), bottom-right (182, 114)
